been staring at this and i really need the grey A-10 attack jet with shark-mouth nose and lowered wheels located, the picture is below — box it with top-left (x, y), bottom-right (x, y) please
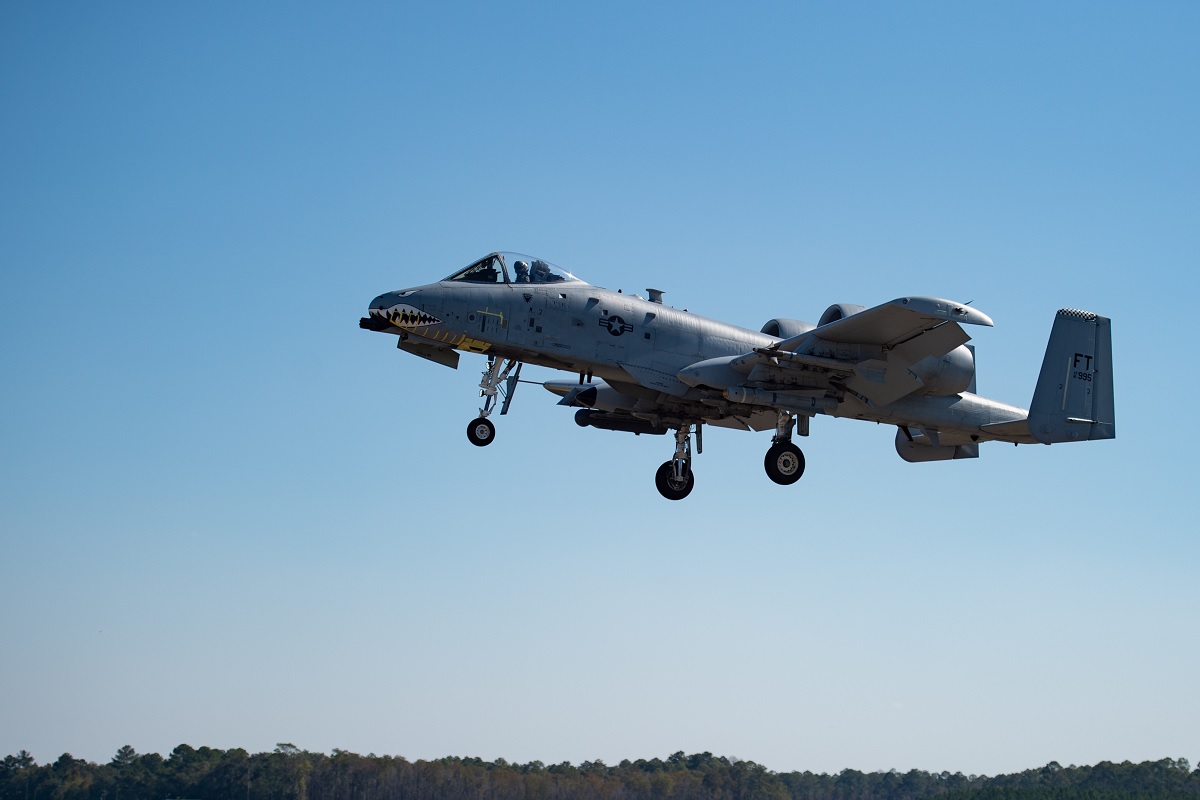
top-left (359, 252), bottom-right (1116, 500)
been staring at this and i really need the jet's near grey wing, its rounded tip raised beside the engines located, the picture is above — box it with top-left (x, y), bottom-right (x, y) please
top-left (774, 297), bottom-right (994, 351)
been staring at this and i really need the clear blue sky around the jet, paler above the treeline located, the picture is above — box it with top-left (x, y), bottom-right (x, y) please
top-left (0, 1), bottom-right (1200, 774)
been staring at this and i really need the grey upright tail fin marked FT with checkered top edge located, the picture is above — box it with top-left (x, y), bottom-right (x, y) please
top-left (1030, 308), bottom-right (1116, 445)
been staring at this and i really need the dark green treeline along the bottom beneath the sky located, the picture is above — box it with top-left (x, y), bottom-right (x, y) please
top-left (0, 744), bottom-right (1200, 800)
